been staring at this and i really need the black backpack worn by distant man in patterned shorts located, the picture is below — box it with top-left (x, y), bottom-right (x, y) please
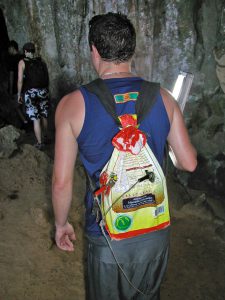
top-left (24, 57), bottom-right (49, 90)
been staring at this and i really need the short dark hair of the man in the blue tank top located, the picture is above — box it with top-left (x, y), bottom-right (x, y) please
top-left (88, 12), bottom-right (136, 63)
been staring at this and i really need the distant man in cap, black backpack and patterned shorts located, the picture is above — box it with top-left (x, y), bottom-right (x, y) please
top-left (17, 43), bottom-right (49, 150)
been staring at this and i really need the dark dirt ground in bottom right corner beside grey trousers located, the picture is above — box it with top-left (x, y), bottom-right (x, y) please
top-left (162, 214), bottom-right (225, 300)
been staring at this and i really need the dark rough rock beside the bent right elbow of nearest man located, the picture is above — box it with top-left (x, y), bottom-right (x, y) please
top-left (179, 93), bottom-right (225, 199)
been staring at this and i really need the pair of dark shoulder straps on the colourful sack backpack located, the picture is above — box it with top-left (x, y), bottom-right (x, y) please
top-left (84, 78), bottom-right (160, 125)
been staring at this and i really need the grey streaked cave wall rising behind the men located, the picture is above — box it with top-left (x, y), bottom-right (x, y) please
top-left (0, 0), bottom-right (225, 98)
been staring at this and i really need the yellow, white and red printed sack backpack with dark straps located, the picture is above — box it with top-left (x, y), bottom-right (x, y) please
top-left (85, 79), bottom-right (170, 240)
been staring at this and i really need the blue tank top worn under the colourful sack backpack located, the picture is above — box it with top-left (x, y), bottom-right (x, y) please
top-left (77, 77), bottom-right (170, 236)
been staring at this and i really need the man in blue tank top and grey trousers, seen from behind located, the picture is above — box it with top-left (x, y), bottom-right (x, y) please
top-left (52, 13), bottom-right (196, 300)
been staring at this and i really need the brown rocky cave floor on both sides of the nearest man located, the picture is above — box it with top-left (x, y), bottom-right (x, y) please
top-left (0, 127), bottom-right (225, 300)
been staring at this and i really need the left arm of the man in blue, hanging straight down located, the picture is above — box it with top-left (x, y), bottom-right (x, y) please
top-left (52, 92), bottom-right (82, 251)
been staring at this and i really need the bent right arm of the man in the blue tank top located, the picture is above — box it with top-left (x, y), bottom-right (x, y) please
top-left (161, 89), bottom-right (197, 172)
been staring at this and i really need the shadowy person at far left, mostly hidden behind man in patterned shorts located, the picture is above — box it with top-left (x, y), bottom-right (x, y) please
top-left (7, 40), bottom-right (28, 125)
